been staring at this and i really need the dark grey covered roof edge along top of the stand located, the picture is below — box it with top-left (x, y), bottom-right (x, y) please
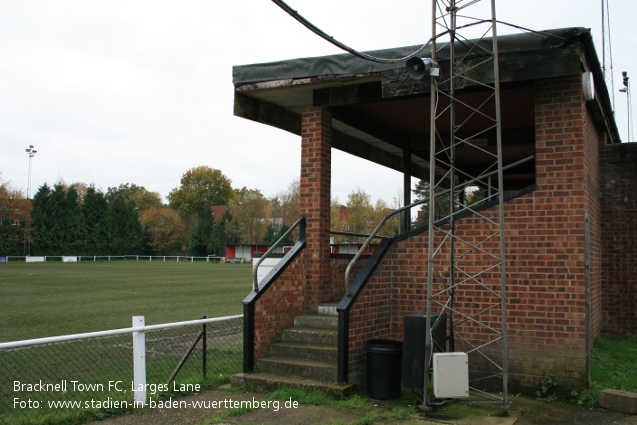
top-left (232, 27), bottom-right (590, 86)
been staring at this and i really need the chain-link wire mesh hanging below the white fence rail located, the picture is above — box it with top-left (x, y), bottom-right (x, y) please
top-left (0, 316), bottom-right (243, 425)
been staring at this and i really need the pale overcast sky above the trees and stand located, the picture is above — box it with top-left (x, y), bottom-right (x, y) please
top-left (0, 0), bottom-right (637, 204)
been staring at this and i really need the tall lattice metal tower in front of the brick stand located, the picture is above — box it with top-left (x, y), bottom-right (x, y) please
top-left (420, 0), bottom-right (509, 412)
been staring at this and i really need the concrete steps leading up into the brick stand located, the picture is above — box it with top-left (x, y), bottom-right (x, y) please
top-left (233, 304), bottom-right (352, 395)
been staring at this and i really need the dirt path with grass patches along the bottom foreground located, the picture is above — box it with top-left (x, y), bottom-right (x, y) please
top-left (85, 390), bottom-right (637, 425)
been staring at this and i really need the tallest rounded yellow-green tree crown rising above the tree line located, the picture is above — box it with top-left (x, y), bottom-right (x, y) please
top-left (168, 166), bottom-right (234, 216)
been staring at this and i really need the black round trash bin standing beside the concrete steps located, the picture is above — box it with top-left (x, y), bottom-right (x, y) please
top-left (366, 339), bottom-right (403, 400)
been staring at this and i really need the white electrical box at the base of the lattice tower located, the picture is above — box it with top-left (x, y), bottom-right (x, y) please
top-left (433, 353), bottom-right (469, 398)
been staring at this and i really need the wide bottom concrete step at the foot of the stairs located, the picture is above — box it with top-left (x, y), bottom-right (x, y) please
top-left (230, 373), bottom-right (354, 397)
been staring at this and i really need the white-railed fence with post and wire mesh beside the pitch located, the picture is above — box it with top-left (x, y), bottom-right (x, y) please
top-left (0, 315), bottom-right (243, 424)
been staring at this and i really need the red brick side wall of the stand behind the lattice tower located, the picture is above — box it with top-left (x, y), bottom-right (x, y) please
top-left (350, 75), bottom-right (601, 388)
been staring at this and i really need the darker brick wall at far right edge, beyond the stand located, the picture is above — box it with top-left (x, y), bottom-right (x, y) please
top-left (600, 143), bottom-right (637, 335)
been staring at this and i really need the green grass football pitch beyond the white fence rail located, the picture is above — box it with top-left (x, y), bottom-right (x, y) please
top-left (0, 260), bottom-right (252, 342)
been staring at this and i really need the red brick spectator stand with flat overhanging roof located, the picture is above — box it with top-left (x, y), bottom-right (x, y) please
top-left (233, 28), bottom-right (637, 394)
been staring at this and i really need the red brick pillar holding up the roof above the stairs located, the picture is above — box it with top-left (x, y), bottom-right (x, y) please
top-left (300, 107), bottom-right (332, 311)
